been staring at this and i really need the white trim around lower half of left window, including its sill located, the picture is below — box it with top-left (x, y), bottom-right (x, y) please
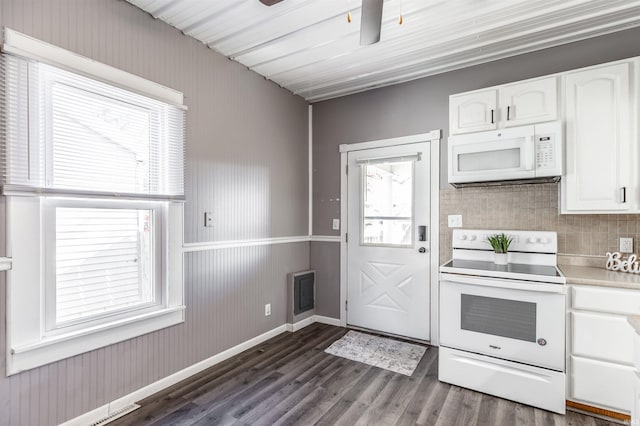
top-left (6, 196), bottom-right (185, 375)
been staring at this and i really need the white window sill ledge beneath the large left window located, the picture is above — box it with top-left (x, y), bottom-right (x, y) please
top-left (7, 306), bottom-right (185, 376)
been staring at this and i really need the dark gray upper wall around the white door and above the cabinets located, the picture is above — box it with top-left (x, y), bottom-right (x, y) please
top-left (313, 28), bottom-right (640, 235)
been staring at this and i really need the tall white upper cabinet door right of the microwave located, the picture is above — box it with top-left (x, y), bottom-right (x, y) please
top-left (561, 63), bottom-right (635, 213)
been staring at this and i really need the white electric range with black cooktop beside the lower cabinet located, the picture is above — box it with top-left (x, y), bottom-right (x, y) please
top-left (438, 229), bottom-right (566, 414)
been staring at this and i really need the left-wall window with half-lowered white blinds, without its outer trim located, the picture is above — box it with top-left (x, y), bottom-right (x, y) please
top-left (0, 54), bottom-right (185, 334)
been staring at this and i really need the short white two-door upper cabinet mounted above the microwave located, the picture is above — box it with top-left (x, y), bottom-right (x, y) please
top-left (449, 76), bottom-right (558, 135)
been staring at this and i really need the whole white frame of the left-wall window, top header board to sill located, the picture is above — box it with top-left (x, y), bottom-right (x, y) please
top-left (0, 28), bottom-right (187, 376)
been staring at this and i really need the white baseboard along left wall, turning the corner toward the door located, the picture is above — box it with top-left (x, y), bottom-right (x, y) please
top-left (61, 315), bottom-right (340, 426)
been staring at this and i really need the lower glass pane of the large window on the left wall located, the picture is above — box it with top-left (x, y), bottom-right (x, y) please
top-left (55, 207), bottom-right (156, 325)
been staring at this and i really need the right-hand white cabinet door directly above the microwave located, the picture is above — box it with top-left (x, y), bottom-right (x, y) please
top-left (498, 77), bottom-right (558, 127)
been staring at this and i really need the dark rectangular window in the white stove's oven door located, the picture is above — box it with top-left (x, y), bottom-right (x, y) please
top-left (460, 294), bottom-right (536, 342)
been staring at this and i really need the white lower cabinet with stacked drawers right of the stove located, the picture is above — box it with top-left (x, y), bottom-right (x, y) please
top-left (567, 285), bottom-right (640, 414)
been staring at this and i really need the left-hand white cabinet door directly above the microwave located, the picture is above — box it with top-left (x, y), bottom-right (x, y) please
top-left (449, 89), bottom-right (498, 135)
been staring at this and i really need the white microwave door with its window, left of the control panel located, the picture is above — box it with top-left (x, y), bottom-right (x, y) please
top-left (449, 126), bottom-right (536, 183)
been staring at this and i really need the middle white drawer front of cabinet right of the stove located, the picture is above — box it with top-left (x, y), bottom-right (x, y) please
top-left (570, 312), bottom-right (636, 366)
